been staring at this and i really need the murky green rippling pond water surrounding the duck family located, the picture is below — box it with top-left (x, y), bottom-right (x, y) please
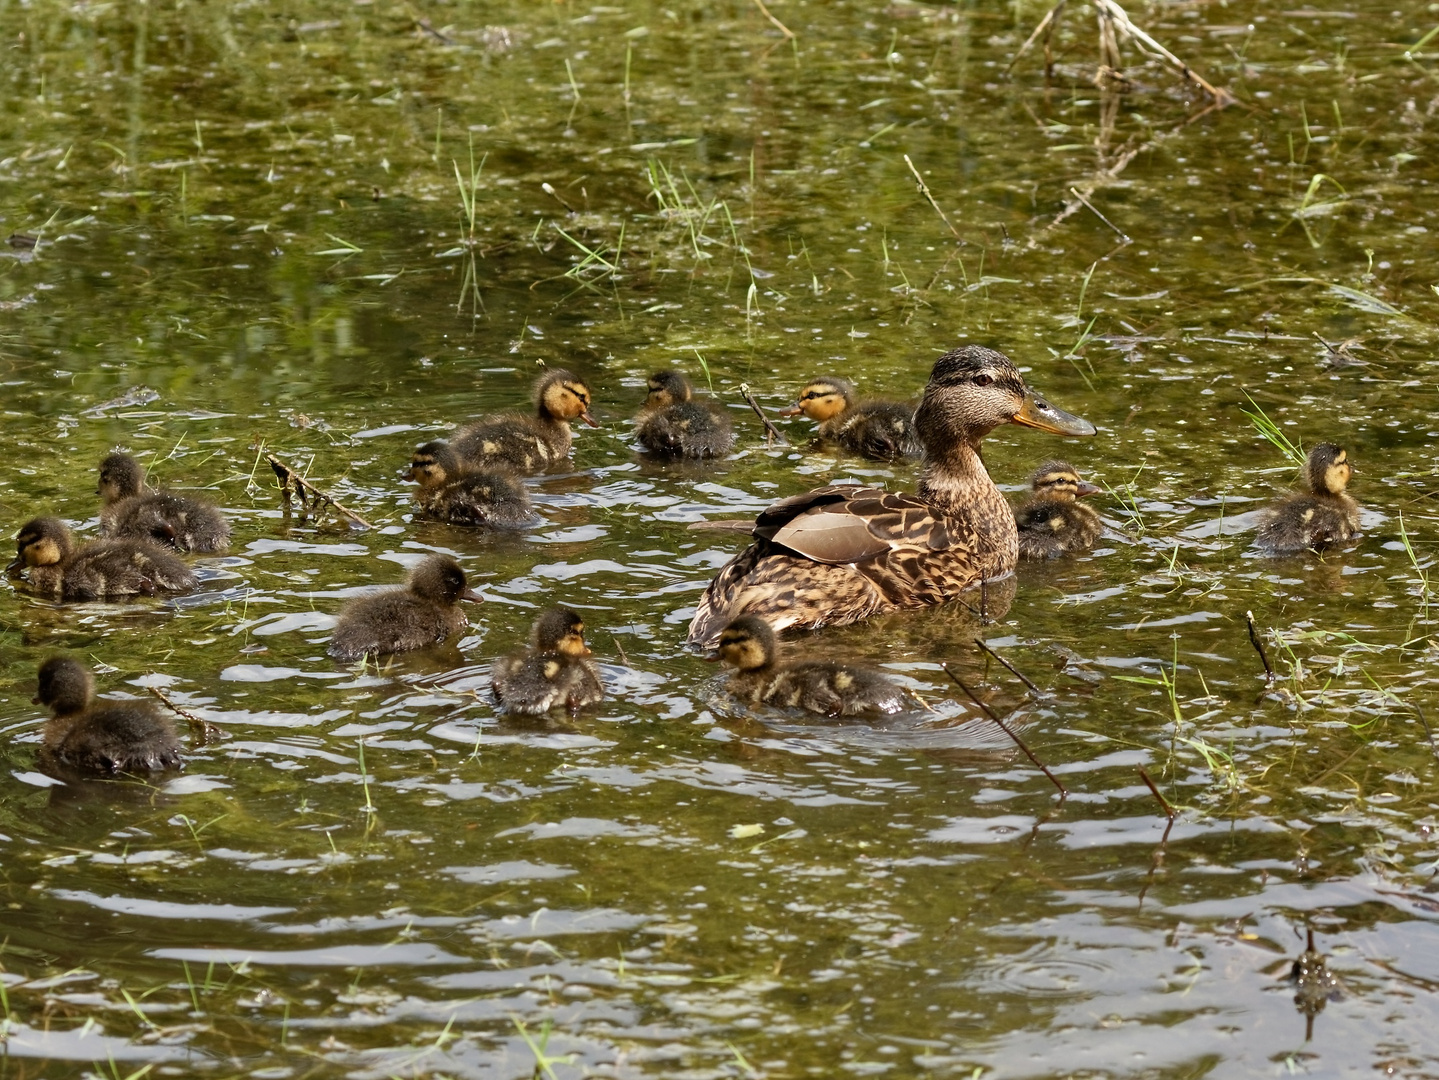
top-left (0, 0), bottom-right (1439, 1079)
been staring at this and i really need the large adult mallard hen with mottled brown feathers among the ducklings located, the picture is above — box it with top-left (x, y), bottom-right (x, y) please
top-left (689, 345), bottom-right (1094, 646)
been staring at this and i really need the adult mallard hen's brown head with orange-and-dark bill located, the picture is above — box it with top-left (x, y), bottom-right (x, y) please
top-left (914, 345), bottom-right (1094, 457)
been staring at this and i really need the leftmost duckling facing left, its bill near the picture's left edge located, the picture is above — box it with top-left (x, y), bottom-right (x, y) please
top-left (6, 518), bottom-right (200, 600)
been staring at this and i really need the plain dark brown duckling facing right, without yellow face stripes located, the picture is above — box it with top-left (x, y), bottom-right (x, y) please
top-left (328, 555), bottom-right (484, 662)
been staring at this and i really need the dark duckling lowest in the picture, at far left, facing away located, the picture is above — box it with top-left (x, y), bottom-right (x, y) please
top-left (35, 656), bottom-right (184, 777)
